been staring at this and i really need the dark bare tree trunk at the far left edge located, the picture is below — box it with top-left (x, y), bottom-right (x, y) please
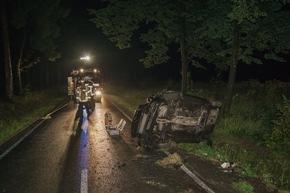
top-left (0, 0), bottom-right (13, 100)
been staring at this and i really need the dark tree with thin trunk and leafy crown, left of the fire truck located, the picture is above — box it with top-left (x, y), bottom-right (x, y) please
top-left (10, 0), bottom-right (68, 93)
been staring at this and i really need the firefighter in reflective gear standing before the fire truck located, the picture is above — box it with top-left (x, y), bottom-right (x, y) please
top-left (76, 81), bottom-right (91, 117)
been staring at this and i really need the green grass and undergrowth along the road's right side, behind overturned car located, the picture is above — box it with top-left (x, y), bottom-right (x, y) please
top-left (108, 81), bottom-right (290, 190)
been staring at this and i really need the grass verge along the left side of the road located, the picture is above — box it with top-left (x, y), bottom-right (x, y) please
top-left (0, 90), bottom-right (66, 144)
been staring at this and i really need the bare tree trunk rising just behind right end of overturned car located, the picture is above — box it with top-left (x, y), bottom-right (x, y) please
top-left (223, 22), bottom-right (240, 115)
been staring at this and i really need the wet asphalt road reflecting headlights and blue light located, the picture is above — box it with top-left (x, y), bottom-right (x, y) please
top-left (0, 95), bottom-right (214, 193)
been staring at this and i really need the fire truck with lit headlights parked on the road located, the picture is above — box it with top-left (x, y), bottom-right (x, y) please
top-left (68, 68), bottom-right (103, 115)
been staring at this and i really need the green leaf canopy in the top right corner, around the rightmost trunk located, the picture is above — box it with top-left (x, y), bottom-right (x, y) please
top-left (208, 0), bottom-right (290, 69)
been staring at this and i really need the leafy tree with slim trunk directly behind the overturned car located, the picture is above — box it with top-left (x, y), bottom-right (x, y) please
top-left (89, 0), bottom-right (203, 94)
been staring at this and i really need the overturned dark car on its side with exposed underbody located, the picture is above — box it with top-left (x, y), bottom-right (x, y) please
top-left (131, 91), bottom-right (221, 148)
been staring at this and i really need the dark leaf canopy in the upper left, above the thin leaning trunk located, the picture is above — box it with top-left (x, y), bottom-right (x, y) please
top-left (10, 0), bottom-right (68, 61)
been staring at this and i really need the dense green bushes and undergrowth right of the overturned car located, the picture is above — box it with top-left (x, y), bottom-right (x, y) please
top-left (205, 81), bottom-right (290, 188)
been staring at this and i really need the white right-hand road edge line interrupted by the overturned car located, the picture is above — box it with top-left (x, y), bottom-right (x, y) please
top-left (106, 97), bottom-right (215, 193)
